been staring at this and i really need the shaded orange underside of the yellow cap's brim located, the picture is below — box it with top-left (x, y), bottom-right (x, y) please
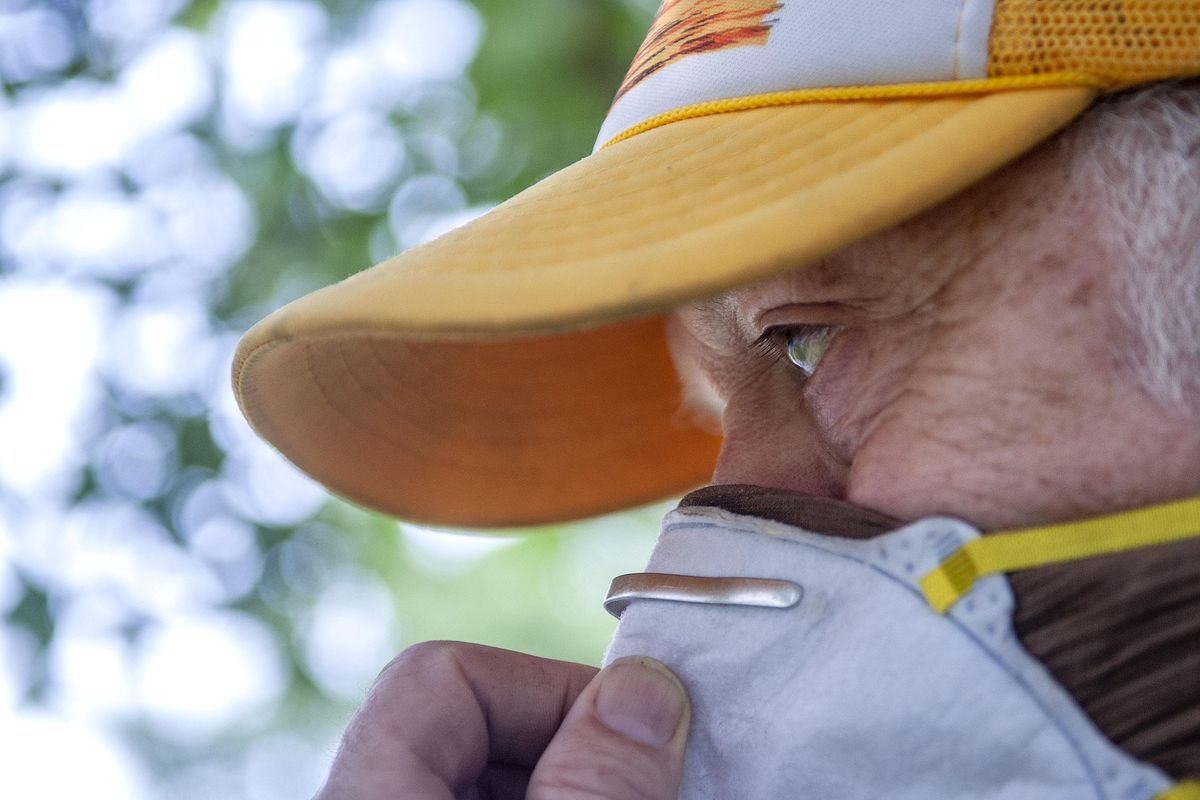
top-left (241, 318), bottom-right (720, 528)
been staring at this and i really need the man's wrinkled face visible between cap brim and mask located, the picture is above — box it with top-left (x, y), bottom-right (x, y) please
top-left (672, 136), bottom-right (1200, 528)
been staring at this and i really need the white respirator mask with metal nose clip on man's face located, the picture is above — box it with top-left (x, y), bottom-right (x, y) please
top-left (606, 501), bottom-right (1200, 800)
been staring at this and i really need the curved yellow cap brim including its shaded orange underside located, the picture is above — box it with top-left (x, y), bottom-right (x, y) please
top-left (234, 88), bottom-right (1096, 527)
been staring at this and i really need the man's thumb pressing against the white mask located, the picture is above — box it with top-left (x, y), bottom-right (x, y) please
top-left (526, 657), bottom-right (691, 800)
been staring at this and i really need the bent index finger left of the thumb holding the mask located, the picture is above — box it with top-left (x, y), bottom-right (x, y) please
top-left (318, 642), bottom-right (596, 800)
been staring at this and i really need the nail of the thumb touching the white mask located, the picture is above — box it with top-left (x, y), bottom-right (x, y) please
top-left (596, 657), bottom-right (688, 747)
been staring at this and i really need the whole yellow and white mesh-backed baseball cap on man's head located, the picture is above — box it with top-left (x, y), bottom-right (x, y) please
top-left (234, 0), bottom-right (1200, 528)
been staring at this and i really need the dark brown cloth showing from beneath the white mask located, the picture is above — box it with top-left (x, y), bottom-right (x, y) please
top-left (679, 485), bottom-right (1200, 778)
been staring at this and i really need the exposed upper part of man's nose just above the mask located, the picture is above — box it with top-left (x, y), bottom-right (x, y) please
top-left (713, 381), bottom-right (846, 498)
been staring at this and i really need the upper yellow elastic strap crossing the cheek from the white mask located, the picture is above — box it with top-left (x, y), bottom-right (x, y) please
top-left (920, 498), bottom-right (1200, 618)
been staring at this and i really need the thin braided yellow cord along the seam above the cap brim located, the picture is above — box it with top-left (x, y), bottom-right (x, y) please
top-left (600, 72), bottom-right (1116, 150)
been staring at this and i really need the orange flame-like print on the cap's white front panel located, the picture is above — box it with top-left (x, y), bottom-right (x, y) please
top-left (613, 0), bottom-right (784, 103)
